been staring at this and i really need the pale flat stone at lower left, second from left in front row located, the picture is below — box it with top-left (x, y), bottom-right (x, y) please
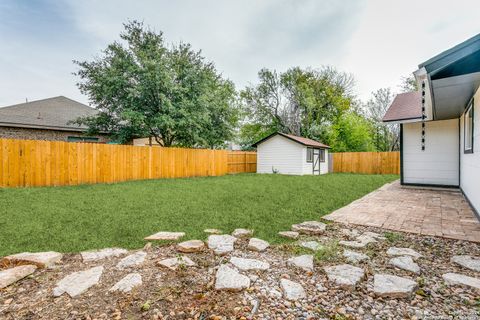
top-left (53, 266), bottom-right (103, 298)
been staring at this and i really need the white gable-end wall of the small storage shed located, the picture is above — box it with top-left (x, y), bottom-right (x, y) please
top-left (257, 135), bottom-right (306, 175)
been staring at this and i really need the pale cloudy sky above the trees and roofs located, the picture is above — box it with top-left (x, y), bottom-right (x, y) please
top-left (0, 0), bottom-right (480, 106)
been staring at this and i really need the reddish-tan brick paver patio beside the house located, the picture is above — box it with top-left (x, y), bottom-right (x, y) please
top-left (323, 181), bottom-right (480, 242)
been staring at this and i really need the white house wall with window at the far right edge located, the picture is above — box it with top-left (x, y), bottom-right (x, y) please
top-left (460, 89), bottom-right (480, 212)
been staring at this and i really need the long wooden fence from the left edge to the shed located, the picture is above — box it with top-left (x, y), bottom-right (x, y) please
top-left (0, 139), bottom-right (256, 187)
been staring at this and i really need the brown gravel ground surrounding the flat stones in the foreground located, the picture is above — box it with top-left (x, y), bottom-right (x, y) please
top-left (0, 224), bottom-right (480, 319)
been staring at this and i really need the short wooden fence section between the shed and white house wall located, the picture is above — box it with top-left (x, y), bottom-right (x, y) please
top-left (332, 151), bottom-right (400, 174)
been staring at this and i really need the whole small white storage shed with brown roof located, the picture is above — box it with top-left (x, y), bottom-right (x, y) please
top-left (254, 132), bottom-right (330, 175)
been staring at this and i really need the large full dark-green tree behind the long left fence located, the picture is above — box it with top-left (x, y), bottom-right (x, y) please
top-left (76, 21), bottom-right (238, 148)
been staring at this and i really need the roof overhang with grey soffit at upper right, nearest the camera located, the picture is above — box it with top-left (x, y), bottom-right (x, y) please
top-left (414, 34), bottom-right (480, 120)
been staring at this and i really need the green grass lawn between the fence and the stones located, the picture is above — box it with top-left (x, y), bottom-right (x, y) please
top-left (0, 174), bottom-right (398, 256)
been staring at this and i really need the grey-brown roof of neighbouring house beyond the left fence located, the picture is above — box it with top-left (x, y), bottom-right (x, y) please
top-left (0, 96), bottom-right (98, 131)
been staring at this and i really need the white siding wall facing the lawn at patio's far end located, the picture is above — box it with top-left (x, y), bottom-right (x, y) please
top-left (403, 119), bottom-right (459, 186)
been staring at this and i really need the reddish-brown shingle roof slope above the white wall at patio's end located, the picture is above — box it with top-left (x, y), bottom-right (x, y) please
top-left (383, 91), bottom-right (422, 122)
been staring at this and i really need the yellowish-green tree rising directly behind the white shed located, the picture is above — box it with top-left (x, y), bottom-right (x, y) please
top-left (240, 67), bottom-right (353, 146)
